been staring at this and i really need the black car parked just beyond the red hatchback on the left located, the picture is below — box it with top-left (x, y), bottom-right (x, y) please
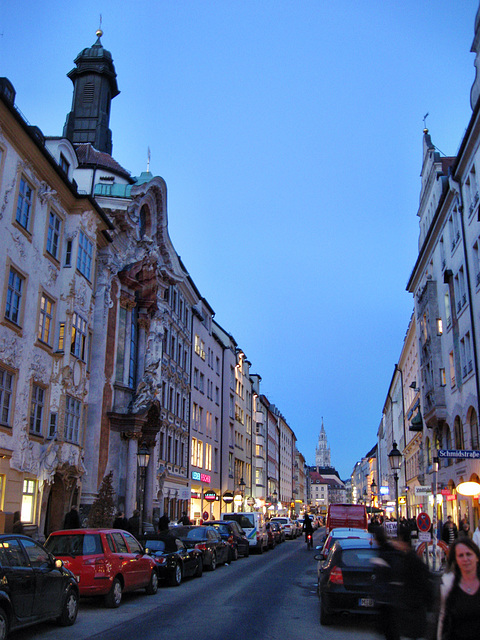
top-left (140, 533), bottom-right (203, 587)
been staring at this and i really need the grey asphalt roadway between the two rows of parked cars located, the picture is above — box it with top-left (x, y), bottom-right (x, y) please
top-left (12, 532), bottom-right (378, 640)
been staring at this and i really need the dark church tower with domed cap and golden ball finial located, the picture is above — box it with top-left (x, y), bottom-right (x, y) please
top-left (63, 29), bottom-right (120, 155)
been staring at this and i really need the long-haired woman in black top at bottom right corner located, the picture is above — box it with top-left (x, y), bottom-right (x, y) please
top-left (437, 538), bottom-right (480, 640)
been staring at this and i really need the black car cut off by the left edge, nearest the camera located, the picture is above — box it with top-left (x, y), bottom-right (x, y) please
top-left (0, 534), bottom-right (79, 640)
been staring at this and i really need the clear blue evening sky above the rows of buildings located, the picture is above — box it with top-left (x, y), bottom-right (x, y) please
top-left (0, 0), bottom-right (478, 478)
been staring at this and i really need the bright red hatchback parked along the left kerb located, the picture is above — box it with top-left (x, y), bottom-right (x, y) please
top-left (45, 529), bottom-right (158, 607)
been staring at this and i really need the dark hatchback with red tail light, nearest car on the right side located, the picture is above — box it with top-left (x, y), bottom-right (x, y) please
top-left (314, 538), bottom-right (378, 625)
